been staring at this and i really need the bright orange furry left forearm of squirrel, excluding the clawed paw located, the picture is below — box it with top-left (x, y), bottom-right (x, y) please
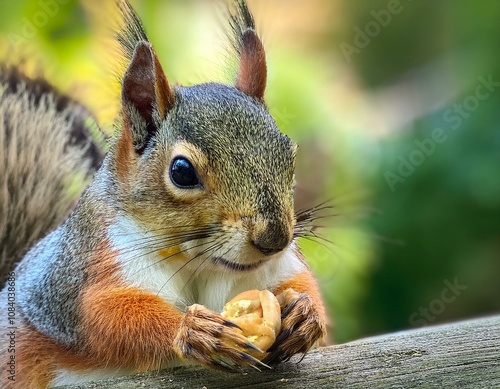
top-left (81, 284), bottom-right (182, 371)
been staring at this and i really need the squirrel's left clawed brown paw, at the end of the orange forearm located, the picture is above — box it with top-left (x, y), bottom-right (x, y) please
top-left (173, 304), bottom-right (268, 371)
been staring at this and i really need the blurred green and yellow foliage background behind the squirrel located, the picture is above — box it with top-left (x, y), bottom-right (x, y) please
top-left (0, 0), bottom-right (500, 342)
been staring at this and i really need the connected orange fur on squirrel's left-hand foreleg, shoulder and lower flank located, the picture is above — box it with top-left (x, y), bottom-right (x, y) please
top-left (0, 233), bottom-right (183, 389)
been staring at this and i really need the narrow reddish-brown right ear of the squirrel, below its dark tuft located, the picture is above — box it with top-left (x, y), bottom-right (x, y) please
top-left (235, 29), bottom-right (267, 100)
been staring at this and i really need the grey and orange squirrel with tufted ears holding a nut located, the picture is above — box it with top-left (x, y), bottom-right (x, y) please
top-left (0, 0), bottom-right (327, 389)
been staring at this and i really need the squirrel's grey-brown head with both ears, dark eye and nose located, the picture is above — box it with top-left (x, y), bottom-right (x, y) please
top-left (110, 1), bottom-right (296, 271)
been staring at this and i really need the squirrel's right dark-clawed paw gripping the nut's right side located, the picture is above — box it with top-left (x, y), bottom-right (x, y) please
top-left (263, 289), bottom-right (326, 364)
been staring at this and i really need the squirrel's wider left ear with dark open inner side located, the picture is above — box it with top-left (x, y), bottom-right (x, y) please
top-left (122, 41), bottom-right (174, 151)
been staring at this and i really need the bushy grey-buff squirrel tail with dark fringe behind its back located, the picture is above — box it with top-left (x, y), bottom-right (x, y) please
top-left (0, 66), bottom-right (105, 288)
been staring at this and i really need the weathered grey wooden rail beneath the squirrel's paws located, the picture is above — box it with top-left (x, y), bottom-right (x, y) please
top-left (56, 316), bottom-right (500, 389)
